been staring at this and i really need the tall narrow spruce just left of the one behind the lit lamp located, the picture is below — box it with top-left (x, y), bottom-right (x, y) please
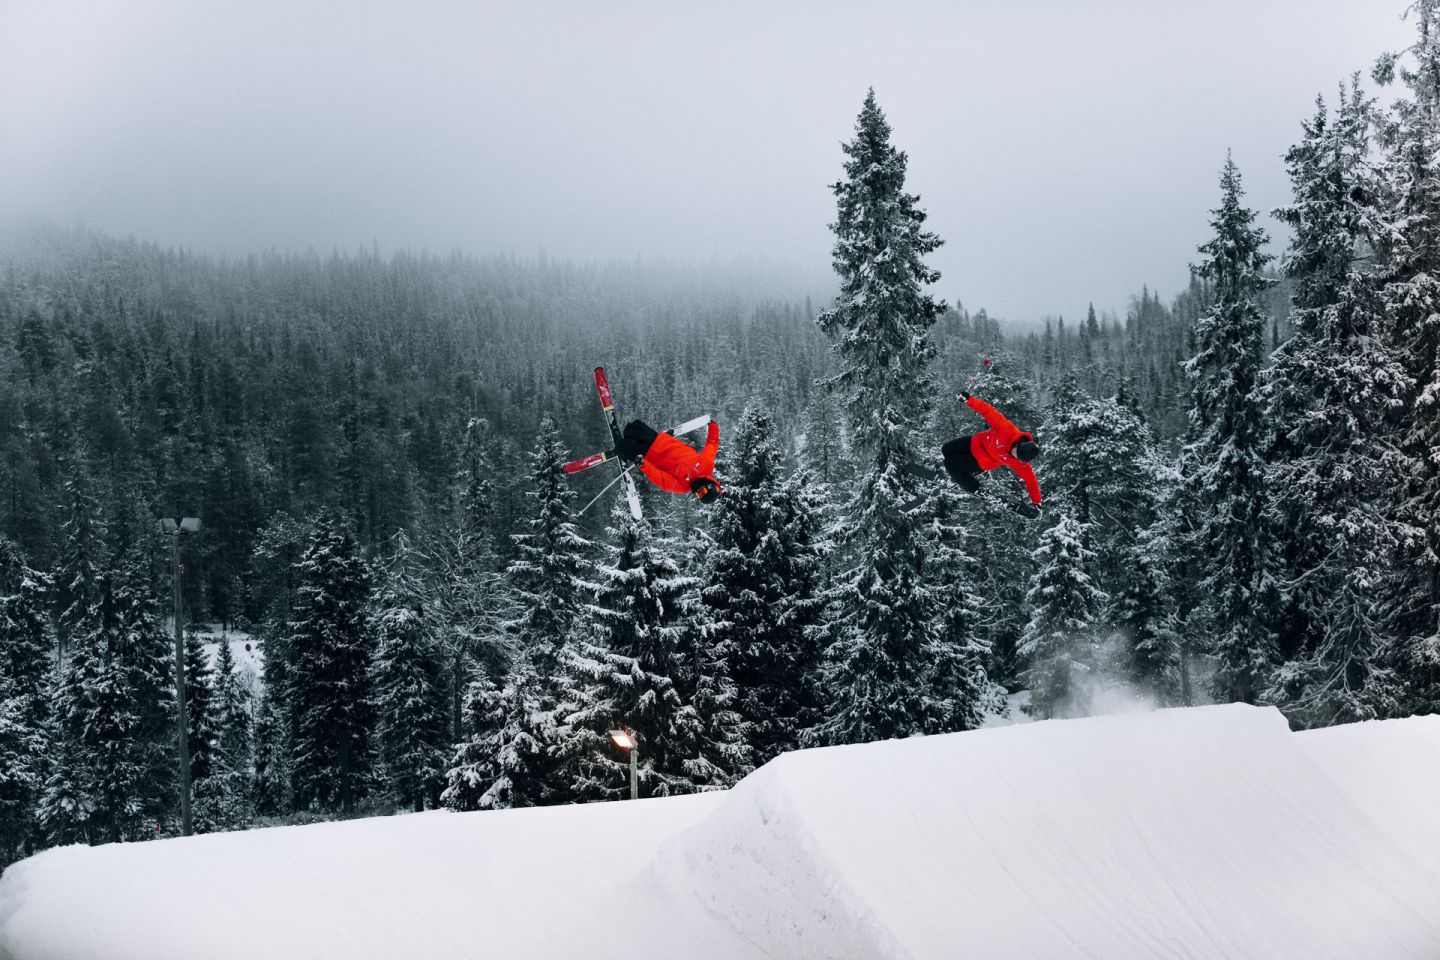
top-left (445, 416), bottom-right (590, 810)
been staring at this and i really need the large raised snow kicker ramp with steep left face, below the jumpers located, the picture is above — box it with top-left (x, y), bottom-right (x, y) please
top-left (662, 705), bottom-right (1440, 960)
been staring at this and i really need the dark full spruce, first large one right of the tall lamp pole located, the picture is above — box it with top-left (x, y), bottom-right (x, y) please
top-left (285, 512), bottom-right (374, 812)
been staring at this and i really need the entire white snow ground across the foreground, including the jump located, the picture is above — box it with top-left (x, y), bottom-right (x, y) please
top-left (0, 705), bottom-right (1440, 960)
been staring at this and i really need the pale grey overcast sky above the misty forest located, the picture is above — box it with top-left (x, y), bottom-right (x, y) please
top-left (0, 0), bottom-right (1411, 321)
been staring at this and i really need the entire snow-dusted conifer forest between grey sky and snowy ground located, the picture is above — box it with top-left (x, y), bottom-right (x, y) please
top-left (0, 0), bottom-right (1440, 862)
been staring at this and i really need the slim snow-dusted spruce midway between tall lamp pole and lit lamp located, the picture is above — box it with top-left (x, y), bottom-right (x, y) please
top-left (373, 530), bottom-right (451, 812)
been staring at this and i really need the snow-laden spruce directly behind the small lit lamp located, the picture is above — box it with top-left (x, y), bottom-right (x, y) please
top-left (564, 498), bottom-right (707, 802)
